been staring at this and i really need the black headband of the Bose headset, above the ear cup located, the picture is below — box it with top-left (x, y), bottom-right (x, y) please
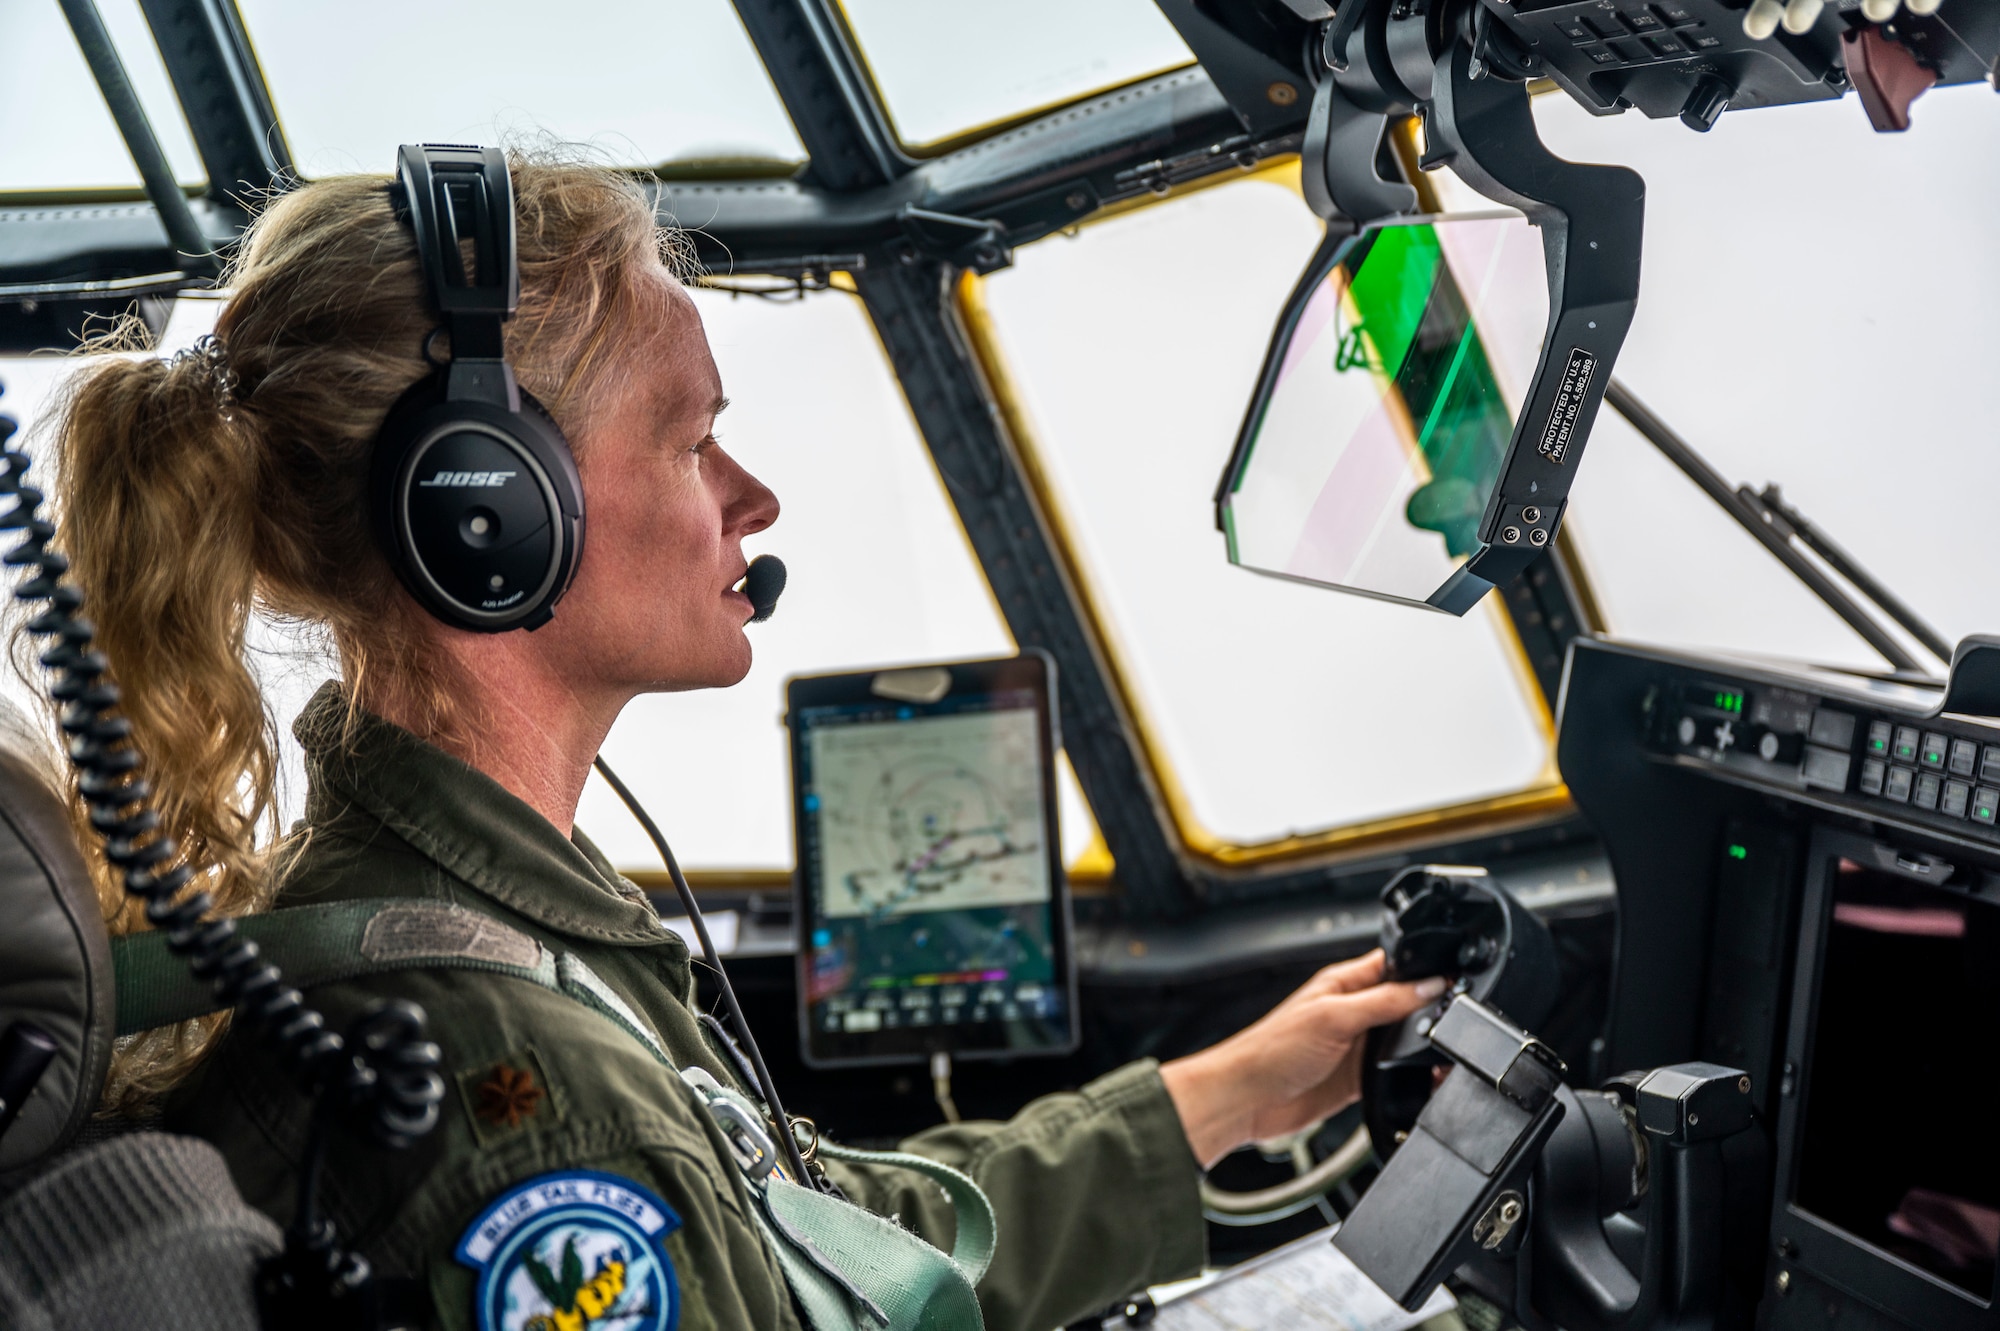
top-left (396, 144), bottom-right (520, 414)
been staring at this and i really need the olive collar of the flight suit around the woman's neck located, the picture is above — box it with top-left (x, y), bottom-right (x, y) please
top-left (292, 681), bottom-right (684, 951)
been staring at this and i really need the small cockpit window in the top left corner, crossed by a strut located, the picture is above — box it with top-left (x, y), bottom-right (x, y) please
top-left (0, 0), bottom-right (206, 196)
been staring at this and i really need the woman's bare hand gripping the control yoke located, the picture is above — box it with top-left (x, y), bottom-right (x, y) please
top-left (1160, 949), bottom-right (1446, 1169)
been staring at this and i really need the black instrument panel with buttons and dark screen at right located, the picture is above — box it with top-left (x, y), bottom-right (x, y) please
top-left (1558, 642), bottom-right (2000, 1331)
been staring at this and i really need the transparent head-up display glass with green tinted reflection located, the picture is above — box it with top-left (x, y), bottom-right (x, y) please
top-left (1216, 212), bottom-right (1560, 614)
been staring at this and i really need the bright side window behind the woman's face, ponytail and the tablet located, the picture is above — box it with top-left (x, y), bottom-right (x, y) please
top-left (0, 290), bottom-right (1110, 885)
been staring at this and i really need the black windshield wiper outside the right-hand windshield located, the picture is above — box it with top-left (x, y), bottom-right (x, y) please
top-left (1604, 380), bottom-right (1952, 675)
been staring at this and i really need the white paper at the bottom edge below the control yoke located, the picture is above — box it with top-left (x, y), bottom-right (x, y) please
top-left (1152, 1229), bottom-right (1458, 1331)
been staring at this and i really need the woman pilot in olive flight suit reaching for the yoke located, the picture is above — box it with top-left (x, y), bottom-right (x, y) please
top-left (56, 160), bottom-right (1442, 1331)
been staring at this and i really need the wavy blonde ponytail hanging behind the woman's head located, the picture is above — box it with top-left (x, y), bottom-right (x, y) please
top-left (52, 337), bottom-right (276, 1109)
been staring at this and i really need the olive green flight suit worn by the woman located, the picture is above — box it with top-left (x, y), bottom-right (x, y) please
top-left (168, 685), bottom-right (1204, 1331)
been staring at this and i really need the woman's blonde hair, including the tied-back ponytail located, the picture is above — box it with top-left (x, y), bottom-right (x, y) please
top-left (41, 154), bottom-right (684, 1111)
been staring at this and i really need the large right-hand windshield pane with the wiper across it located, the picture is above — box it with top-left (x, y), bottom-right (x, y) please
top-left (1536, 86), bottom-right (2000, 671)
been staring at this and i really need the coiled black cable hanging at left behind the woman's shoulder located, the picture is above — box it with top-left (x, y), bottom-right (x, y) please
top-left (0, 391), bottom-right (444, 1147)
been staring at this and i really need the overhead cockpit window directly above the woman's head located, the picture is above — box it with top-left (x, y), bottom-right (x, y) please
top-left (238, 0), bottom-right (806, 178)
